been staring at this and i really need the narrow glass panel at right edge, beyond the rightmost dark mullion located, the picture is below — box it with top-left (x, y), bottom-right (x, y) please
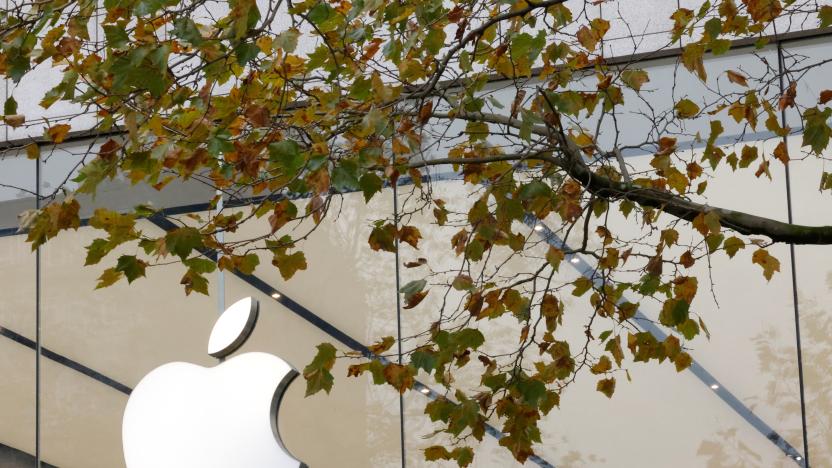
top-left (782, 34), bottom-right (832, 466)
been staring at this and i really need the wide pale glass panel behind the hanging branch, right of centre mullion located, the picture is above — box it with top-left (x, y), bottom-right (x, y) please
top-left (401, 148), bottom-right (802, 467)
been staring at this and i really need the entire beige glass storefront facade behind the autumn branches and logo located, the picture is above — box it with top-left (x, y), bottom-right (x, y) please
top-left (0, 4), bottom-right (832, 468)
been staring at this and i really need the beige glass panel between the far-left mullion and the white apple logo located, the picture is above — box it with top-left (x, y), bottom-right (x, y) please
top-left (41, 221), bottom-right (217, 468)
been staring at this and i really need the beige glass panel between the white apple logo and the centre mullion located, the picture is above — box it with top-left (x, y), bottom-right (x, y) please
top-left (225, 190), bottom-right (401, 468)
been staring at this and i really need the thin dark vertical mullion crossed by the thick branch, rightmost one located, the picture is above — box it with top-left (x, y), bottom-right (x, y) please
top-left (777, 41), bottom-right (809, 468)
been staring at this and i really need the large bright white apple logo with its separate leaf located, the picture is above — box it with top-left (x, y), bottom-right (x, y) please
top-left (122, 297), bottom-right (306, 468)
